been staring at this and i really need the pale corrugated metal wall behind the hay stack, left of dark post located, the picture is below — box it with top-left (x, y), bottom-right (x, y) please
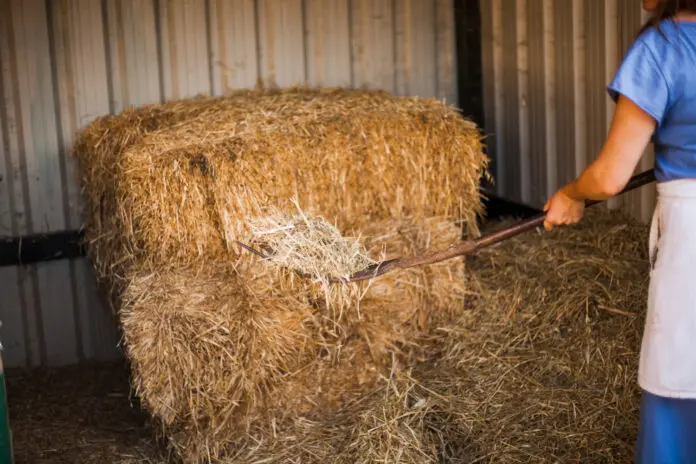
top-left (0, 0), bottom-right (457, 366)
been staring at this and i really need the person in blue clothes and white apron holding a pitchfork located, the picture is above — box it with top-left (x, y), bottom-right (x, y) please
top-left (544, 0), bottom-right (696, 463)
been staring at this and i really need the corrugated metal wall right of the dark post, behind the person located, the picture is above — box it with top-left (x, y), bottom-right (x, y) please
top-left (480, 0), bottom-right (654, 220)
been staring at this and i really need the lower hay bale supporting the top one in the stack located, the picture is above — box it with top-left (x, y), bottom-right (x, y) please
top-left (121, 218), bottom-right (465, 462)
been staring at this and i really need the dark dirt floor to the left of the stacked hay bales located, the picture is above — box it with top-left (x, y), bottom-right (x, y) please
top-left (5, 364), bottom-right (168, 464)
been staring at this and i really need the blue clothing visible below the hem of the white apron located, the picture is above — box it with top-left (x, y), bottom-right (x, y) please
top-left (636, 391), bottom-right (696, 464)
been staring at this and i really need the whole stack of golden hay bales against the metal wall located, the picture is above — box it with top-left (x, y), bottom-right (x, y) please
top-left (75, 89), bottom-right (486, 462)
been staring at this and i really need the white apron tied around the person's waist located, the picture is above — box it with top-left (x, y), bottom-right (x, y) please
top-left (638, 180), bottom-right (696, 398)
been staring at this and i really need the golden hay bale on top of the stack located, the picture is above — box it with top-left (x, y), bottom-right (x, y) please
top-left (75, 88), bottom-right (487, 281)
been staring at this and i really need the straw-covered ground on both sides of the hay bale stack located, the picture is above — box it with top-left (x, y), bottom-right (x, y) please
top-left (7, 212), bottom-right (648, 464)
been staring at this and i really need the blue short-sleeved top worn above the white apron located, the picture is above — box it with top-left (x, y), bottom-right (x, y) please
top-left (608, 20), bottom-right (696, 182)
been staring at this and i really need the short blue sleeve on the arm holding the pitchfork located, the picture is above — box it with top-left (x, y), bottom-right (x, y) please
top-left (607, 39), bottom-right (670, 125)
